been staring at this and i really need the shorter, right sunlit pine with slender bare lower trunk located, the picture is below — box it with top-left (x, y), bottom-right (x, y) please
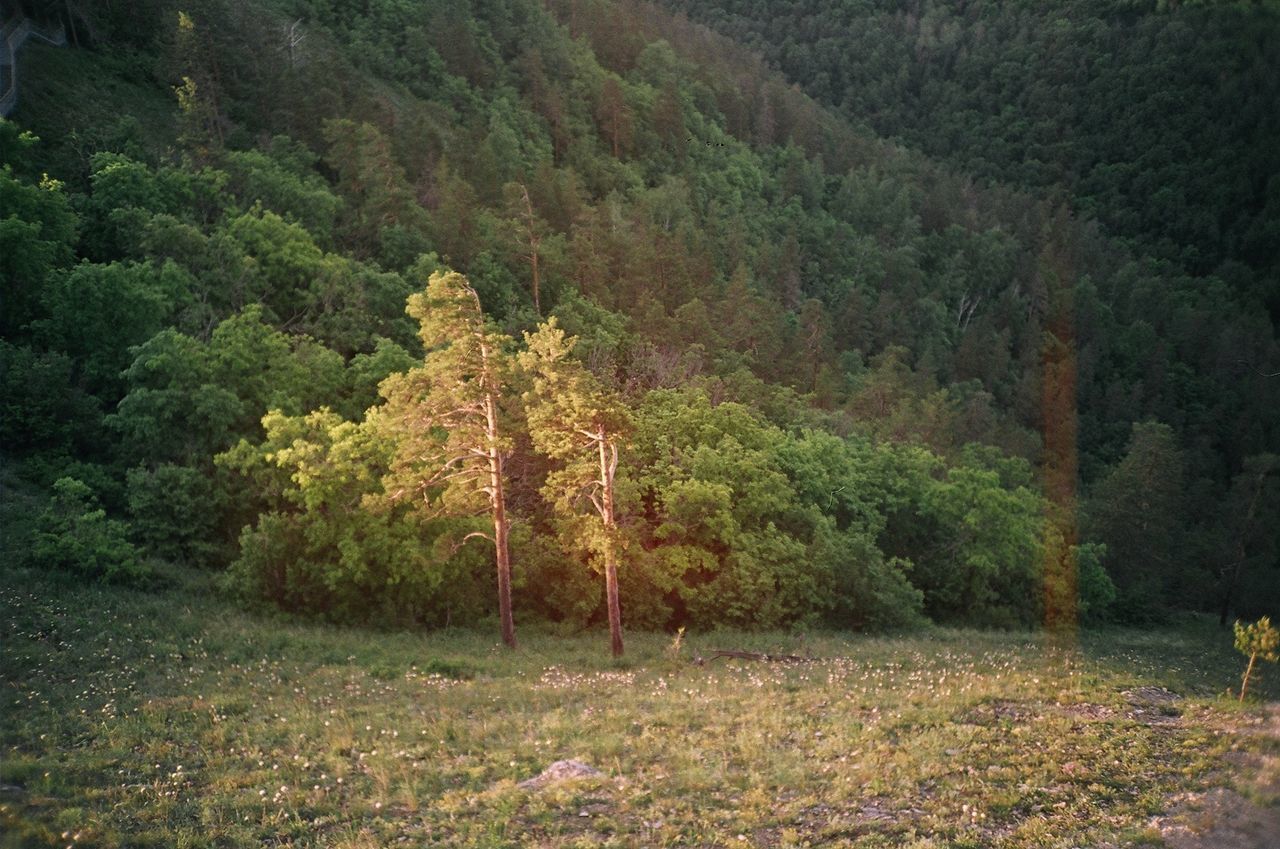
top-left (520, 318), bottom-right (631, 657)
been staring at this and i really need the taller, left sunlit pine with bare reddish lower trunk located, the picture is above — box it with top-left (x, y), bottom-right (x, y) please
top-left (370, 271), bottom-right (516, 648)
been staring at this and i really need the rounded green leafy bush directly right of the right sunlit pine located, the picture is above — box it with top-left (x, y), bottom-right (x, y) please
top-left (624, 392), bottom-right (814, 626)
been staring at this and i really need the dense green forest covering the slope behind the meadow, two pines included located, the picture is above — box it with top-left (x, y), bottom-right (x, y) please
top-left (0, 0), bottom-right (1280, 633)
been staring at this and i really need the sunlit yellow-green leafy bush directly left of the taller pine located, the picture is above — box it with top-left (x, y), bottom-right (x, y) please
top-left (219, 408), bottom-right (477, 622)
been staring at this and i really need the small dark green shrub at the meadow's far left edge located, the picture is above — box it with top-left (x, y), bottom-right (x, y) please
top-left (26, 478), bottom-right (152, 585)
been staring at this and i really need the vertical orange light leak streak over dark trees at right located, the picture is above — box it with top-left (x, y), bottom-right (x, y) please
top-left (1041, 233), bottom-right (1079, 647)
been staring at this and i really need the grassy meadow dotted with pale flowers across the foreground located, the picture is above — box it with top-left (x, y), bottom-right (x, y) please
top-left (0, 560), bottom-right (1280, 848)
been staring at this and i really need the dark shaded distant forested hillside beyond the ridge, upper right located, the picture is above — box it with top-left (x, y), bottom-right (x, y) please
top-left (666, 0), bottom-right (1280, 320)
